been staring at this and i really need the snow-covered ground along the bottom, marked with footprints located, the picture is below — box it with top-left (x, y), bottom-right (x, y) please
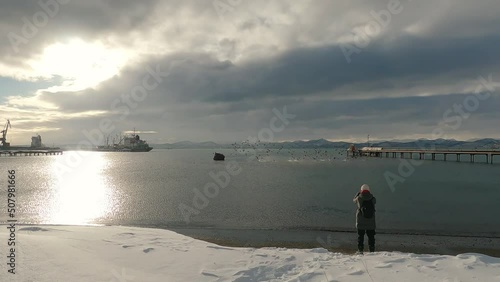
top-left (0, 226), bottom-right (500, 282)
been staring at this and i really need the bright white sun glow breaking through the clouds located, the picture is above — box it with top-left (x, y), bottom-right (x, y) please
top-left (30, 39), bottom-right (127, 91)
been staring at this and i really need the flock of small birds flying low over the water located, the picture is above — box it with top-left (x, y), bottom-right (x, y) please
top-left (231, 140), bottom-right (347, 161)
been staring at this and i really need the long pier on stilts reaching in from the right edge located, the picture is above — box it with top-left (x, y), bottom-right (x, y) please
top-left (357, 147), bottom-right (500, 164)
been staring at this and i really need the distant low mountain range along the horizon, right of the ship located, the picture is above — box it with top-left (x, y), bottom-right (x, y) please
top-left (151, 138), bottom-right (500, 149)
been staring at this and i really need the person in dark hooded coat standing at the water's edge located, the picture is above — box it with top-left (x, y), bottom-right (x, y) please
top-left (353, 184), bottom-right (377, 254)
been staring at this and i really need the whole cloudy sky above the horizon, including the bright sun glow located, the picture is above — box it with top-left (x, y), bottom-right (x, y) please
top-left (0, 0), bottom-right (500, 145)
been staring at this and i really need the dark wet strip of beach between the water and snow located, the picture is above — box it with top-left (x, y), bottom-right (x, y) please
top-left (168, 228), bottom-right (500, 258)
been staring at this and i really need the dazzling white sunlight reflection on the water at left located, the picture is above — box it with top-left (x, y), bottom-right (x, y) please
top-left (45, 152), bottom-right (114, 224)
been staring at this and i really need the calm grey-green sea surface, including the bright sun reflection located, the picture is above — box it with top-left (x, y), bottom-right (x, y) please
top-left (0, 149), bottom-right (500, 236)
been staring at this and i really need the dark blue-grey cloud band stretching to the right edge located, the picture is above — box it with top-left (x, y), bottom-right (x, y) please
top-left (193, 33), bottom-right (500, 101)
